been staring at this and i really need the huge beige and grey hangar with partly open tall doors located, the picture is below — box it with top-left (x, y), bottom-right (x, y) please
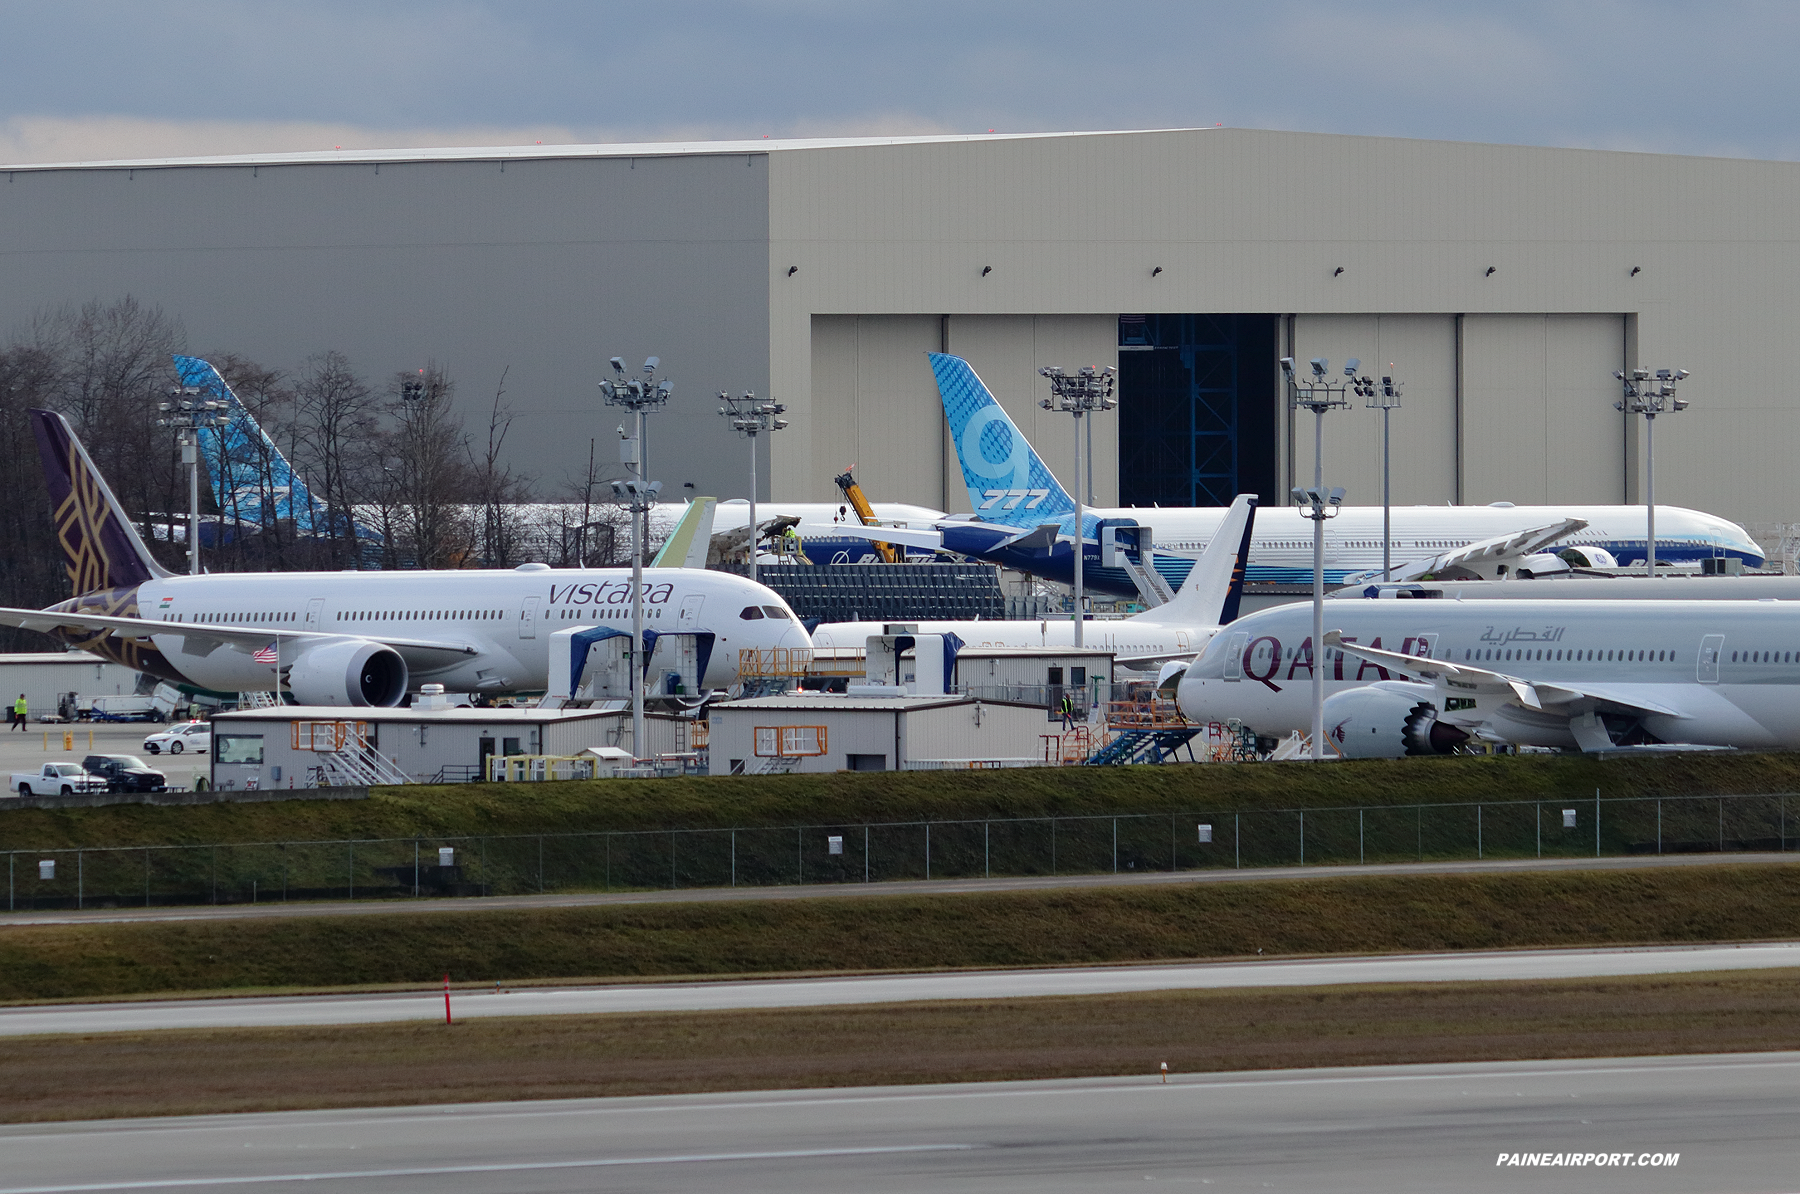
top-left (0, 128), bottom-right (1800, 522)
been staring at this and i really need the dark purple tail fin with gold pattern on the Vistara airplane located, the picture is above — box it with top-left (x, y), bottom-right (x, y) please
top-left (29, 411), bottom-right (171, 596)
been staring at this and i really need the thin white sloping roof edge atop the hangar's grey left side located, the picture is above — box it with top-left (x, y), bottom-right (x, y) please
top-left (0, 130), bottom-right (1152, 171)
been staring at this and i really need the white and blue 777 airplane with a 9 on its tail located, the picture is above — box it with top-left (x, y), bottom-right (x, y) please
top-left (931, 353), bottom-right (1762, 596)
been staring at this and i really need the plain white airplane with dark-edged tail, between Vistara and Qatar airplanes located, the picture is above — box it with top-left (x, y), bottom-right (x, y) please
top-left (812, 493), bottom-right (1256, 668)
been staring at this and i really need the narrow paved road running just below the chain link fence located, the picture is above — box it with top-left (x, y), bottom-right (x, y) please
top-left (0, 852), bottom-right (1800, 929)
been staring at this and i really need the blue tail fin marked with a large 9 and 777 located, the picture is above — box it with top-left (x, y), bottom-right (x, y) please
top-left (931, 353), bottom-right (1075, 526)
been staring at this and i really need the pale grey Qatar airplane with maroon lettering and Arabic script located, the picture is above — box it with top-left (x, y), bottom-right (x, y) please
top-left (1175, 597), bottom-right (1800, 758)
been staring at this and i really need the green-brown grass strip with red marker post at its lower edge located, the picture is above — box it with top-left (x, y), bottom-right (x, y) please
top-left (0, 864), bottom-right (1800, 1001)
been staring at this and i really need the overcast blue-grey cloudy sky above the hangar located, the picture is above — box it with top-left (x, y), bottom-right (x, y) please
top-left (0, 0), bottom-right (1800, 162)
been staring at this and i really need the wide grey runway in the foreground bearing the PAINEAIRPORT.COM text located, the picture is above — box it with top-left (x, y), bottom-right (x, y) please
top-left (0, 1054), bottom-right (1800, 1194)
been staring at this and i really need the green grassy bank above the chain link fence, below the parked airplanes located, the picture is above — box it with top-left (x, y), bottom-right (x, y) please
top-left (0, 753), bottom-right (1800, 850)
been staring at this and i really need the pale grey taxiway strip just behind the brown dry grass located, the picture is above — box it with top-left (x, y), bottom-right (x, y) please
top-left (0, 942), bottom-right (1800, 1036)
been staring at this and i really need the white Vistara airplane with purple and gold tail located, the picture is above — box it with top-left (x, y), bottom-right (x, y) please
top-left (0, 411), bottom-right (810, 706)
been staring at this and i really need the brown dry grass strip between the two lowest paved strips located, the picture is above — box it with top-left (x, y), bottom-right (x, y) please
top-left (0, 971), bottom-right (1800, 1122)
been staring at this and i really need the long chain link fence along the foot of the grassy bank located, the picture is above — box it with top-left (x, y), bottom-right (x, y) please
top-left (4, 794), bottom-right (1800, 911)
